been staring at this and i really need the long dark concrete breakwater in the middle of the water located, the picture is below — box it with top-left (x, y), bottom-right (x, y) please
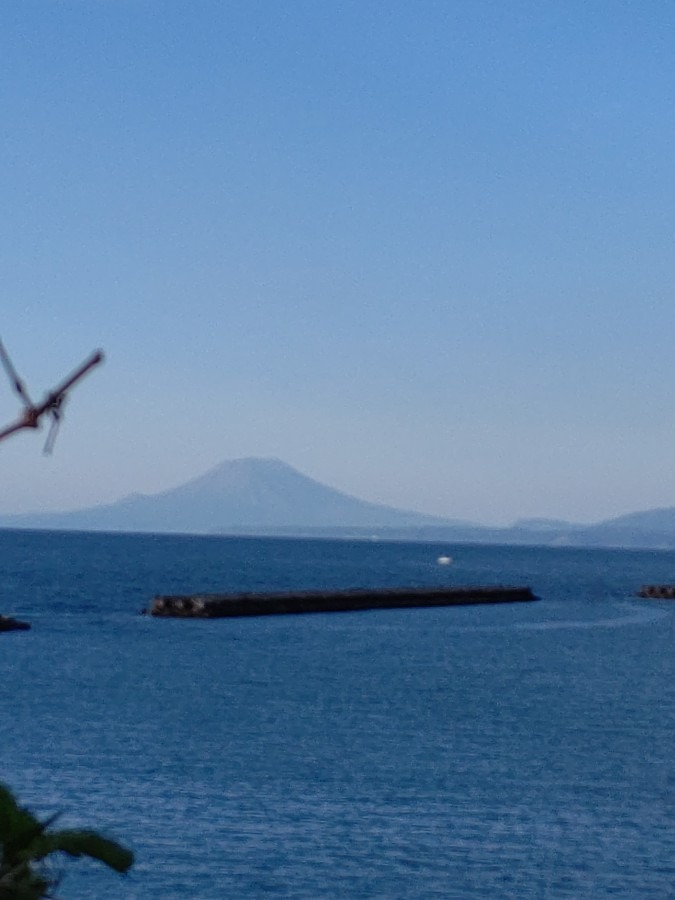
top-left (148, 586), bottom-right (539, 619)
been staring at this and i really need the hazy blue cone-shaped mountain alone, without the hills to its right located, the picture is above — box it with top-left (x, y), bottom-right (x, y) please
top-left (2, 458), bottom-right (468, 533)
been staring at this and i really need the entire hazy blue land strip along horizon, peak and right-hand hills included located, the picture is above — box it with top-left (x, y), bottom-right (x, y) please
top-left (0, 457), bottom-right (675, 549)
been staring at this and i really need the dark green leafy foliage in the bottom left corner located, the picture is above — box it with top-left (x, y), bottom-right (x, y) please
top-left (0, 784), bottom-right (134, 900)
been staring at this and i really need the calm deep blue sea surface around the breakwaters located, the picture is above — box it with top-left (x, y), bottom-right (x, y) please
top-left (0, 531), bottom-right (675, 900)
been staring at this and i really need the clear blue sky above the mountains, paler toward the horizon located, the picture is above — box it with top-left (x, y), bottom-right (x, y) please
top-left (0, 0), bottom-right (675, 523)
